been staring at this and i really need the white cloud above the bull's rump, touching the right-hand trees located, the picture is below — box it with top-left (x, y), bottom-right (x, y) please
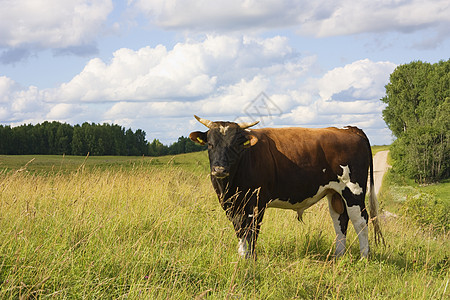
top-left (277, 59), bottom-right (396, 139)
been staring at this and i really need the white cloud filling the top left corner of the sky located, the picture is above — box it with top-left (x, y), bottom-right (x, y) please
top-left (0, 0), bottom-right (113, 48)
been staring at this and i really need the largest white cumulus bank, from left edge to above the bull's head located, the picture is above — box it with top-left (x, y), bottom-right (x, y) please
top-left (0, 36), bottom-right (304, 127)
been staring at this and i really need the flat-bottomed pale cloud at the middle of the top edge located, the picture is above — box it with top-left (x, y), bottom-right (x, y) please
top-left (129, 0), bottom-right (305, 32)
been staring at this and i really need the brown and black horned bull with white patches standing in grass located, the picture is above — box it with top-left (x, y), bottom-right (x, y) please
top-left (189, 116), bottom-right (384, 258)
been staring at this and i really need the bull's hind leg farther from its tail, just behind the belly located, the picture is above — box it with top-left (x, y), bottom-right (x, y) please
top-left (327, 193), bottom-right (349, 257)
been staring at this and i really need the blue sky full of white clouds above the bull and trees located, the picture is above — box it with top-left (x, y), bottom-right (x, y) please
top-left (0, 0), bottom-right (450, 145)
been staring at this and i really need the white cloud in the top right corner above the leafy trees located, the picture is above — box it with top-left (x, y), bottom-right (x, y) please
top-left (299, 0), bottom-right (450, 37)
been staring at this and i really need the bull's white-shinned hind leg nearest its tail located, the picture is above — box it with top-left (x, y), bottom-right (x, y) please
top-left (344, 189), bottom-right (369, 257)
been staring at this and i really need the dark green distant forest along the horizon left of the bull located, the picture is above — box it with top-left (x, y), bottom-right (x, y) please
top-left (0, 122), bottom-right (206, 156)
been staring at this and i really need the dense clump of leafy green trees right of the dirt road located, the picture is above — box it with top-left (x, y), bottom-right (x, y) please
top-left (381, 60), bottom-right (450, 183)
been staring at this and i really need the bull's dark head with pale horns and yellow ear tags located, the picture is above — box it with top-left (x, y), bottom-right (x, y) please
top-left (189, 116), bottom-right (259, 178)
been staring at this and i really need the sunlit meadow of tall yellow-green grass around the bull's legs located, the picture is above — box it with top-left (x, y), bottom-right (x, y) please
top-left (0, 152), bottom-right (450, 299)
